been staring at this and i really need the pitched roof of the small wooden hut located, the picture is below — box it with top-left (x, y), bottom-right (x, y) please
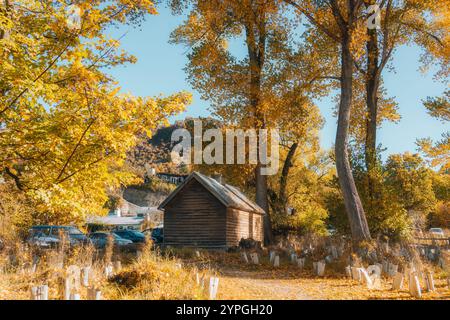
top-left (159, 172), bottom-right (264, 214)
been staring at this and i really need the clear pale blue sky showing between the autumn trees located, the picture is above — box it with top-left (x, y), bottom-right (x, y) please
top-left (110, 8), bottom-right (450, 160)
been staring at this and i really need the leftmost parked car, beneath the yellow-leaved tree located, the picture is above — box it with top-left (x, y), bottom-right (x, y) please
top-left (27, 226), bottom-right (91, 248)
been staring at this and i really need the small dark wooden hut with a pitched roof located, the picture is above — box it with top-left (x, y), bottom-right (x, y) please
top-left (159, 172), bottom-right (265, 249)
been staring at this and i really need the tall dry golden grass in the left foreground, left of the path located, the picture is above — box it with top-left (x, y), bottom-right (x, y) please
top-left (0, 244), bottom-right (208, 300)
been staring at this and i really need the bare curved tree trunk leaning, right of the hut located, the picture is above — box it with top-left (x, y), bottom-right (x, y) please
top-left (335, 31), bottom-right (370, 242)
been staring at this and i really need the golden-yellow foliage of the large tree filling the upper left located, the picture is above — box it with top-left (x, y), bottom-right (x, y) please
top-left (0, 0), bottom-right (191, 221)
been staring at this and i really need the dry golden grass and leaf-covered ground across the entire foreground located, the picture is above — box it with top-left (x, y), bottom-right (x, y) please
top-left (0, 238), bottom-right (450, 300)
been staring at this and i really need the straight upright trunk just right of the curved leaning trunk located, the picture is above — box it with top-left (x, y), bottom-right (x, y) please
top-left (364, 6), bottom-right (380, 201)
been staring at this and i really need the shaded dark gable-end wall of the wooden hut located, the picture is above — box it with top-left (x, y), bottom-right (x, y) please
top-left (164, 179), bottom-right (226, 248)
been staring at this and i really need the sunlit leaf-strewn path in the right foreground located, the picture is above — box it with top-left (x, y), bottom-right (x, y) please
top-left (214, 269), bottom-right (450, 300)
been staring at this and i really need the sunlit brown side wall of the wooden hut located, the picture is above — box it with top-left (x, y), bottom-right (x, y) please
top-left (227, 208), bottom-right (263, 247)
